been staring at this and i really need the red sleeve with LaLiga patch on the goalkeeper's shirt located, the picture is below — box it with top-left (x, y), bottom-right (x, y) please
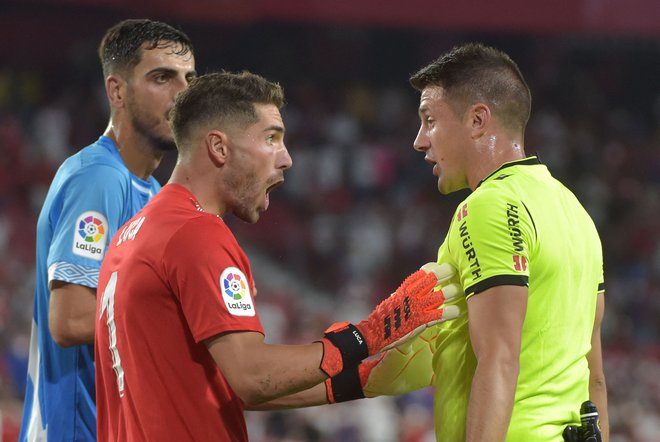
top-left (163, 216), bottom-right (263, 342)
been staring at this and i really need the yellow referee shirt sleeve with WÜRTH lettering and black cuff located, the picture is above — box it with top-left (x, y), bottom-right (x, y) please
top-left (448, 189), bottom-right (536, 298)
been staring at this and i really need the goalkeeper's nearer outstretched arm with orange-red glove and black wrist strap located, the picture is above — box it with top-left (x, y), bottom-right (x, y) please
top-left (206, 263), bottom-right (458, 408)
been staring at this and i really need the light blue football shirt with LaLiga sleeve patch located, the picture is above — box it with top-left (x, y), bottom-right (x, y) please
top-left (20, 136), bottom-right (160, 441)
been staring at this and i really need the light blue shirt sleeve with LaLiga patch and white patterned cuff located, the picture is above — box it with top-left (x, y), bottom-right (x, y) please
top-left (48, 165), bottom-right (130, 288)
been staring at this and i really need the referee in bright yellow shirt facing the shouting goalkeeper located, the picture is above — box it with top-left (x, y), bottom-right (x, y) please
top-left (410, 44), bottom-right (608, 442)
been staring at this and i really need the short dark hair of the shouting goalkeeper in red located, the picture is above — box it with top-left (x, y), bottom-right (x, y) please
top-left (170, 71), bottom-right (284, 148)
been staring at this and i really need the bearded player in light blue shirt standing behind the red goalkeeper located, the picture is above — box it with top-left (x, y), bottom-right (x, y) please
top-left (20, 19), bottom-right (195, 441)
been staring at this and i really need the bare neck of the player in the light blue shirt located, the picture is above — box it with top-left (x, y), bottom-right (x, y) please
top-left (103, 120), bottom-right (163, 180)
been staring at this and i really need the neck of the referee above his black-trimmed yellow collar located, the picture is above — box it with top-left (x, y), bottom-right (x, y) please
top-left (467, 135), bottom-right (525, 190)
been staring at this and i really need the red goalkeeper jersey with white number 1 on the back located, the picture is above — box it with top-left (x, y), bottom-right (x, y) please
top-left (95, 184), bottom-right (263, 442)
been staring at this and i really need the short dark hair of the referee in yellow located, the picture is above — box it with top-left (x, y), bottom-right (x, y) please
top-left (410, 43), bottom-right (532, 130)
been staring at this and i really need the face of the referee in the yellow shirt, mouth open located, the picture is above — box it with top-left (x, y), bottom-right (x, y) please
top-left (413, 86), bottom-right (470, 194)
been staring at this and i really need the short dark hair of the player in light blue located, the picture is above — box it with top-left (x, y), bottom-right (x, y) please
top-left (99, 19), bottom-right (194, 77)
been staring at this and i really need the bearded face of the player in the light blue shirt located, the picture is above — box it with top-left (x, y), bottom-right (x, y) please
top-left (126, 43), bottom-right (195, 151)
